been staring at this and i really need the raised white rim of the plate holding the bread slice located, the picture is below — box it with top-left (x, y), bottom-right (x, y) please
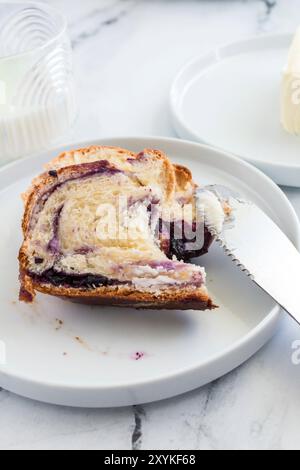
top-left (0, 136), bottom-right (300, 407)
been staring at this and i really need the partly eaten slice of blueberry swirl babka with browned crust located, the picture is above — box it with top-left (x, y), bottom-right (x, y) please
top-left (19, 147), bottom-right (229, 310)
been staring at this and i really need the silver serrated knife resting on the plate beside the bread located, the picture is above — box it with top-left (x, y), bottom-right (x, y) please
top-left (206, 186), bottom-right (300, 325)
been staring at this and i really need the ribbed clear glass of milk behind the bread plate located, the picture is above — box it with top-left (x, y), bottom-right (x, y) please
top-left (0, 2), bottom-right (76, 165)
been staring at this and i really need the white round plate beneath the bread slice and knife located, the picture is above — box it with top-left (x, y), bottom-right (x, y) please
top-left (0, 138), bottom-right (300, 407)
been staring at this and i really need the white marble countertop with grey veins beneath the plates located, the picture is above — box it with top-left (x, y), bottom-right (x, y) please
top-left (0, 0), bottom-right (300, 450)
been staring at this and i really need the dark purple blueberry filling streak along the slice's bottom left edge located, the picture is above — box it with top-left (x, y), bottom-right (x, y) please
top-left (31, 269), bottom-right (128, 289)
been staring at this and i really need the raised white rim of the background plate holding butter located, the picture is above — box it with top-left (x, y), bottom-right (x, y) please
top-left (169, 33), bottom-right (300, 186)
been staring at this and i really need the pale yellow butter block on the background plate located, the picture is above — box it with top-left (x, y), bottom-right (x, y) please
top-left (281, 28), bottom-right (300, 135)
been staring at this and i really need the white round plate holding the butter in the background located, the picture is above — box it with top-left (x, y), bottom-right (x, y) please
top-left (171, 34), bottom-right (300, 187)
